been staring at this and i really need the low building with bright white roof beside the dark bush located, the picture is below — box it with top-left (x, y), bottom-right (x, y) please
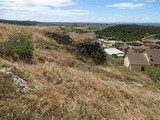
top-left (104, 48), bottom-right (125, 57)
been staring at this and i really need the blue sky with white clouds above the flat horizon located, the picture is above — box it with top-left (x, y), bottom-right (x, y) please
top-left (0, 0), bottom-right (160, 23)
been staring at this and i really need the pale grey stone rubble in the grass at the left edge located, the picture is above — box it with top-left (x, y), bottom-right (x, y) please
top-left (0, 68), bottom-right (31, 93)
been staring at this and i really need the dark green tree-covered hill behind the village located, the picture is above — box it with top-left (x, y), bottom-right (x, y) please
top-left (96, 25), bottom-right (160, 41)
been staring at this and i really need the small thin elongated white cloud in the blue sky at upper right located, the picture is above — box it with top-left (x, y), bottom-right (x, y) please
top-left (106, 3), bottom-right (144, 9)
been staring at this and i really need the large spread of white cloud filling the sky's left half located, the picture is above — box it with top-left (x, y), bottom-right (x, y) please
top-left (0, 0), bottom-right (91, 19)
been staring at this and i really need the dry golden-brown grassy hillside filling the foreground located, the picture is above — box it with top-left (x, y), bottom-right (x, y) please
top-left (0, 24), bottom-right (160, 120)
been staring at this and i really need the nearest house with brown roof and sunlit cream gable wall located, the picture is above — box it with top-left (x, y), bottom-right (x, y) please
top-left (124, 53), bottom-right (150, 71)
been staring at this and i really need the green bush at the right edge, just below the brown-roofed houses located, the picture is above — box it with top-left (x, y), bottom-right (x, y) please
top-left (145, 66), bottom-right (160, 82)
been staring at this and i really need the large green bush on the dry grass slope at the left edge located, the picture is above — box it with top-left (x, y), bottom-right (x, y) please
top-left (0, 34), bottom-right (34, 60)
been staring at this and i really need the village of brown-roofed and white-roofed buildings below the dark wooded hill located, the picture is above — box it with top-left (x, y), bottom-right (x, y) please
top-left (97, 36), bottom-right (160, 71)
